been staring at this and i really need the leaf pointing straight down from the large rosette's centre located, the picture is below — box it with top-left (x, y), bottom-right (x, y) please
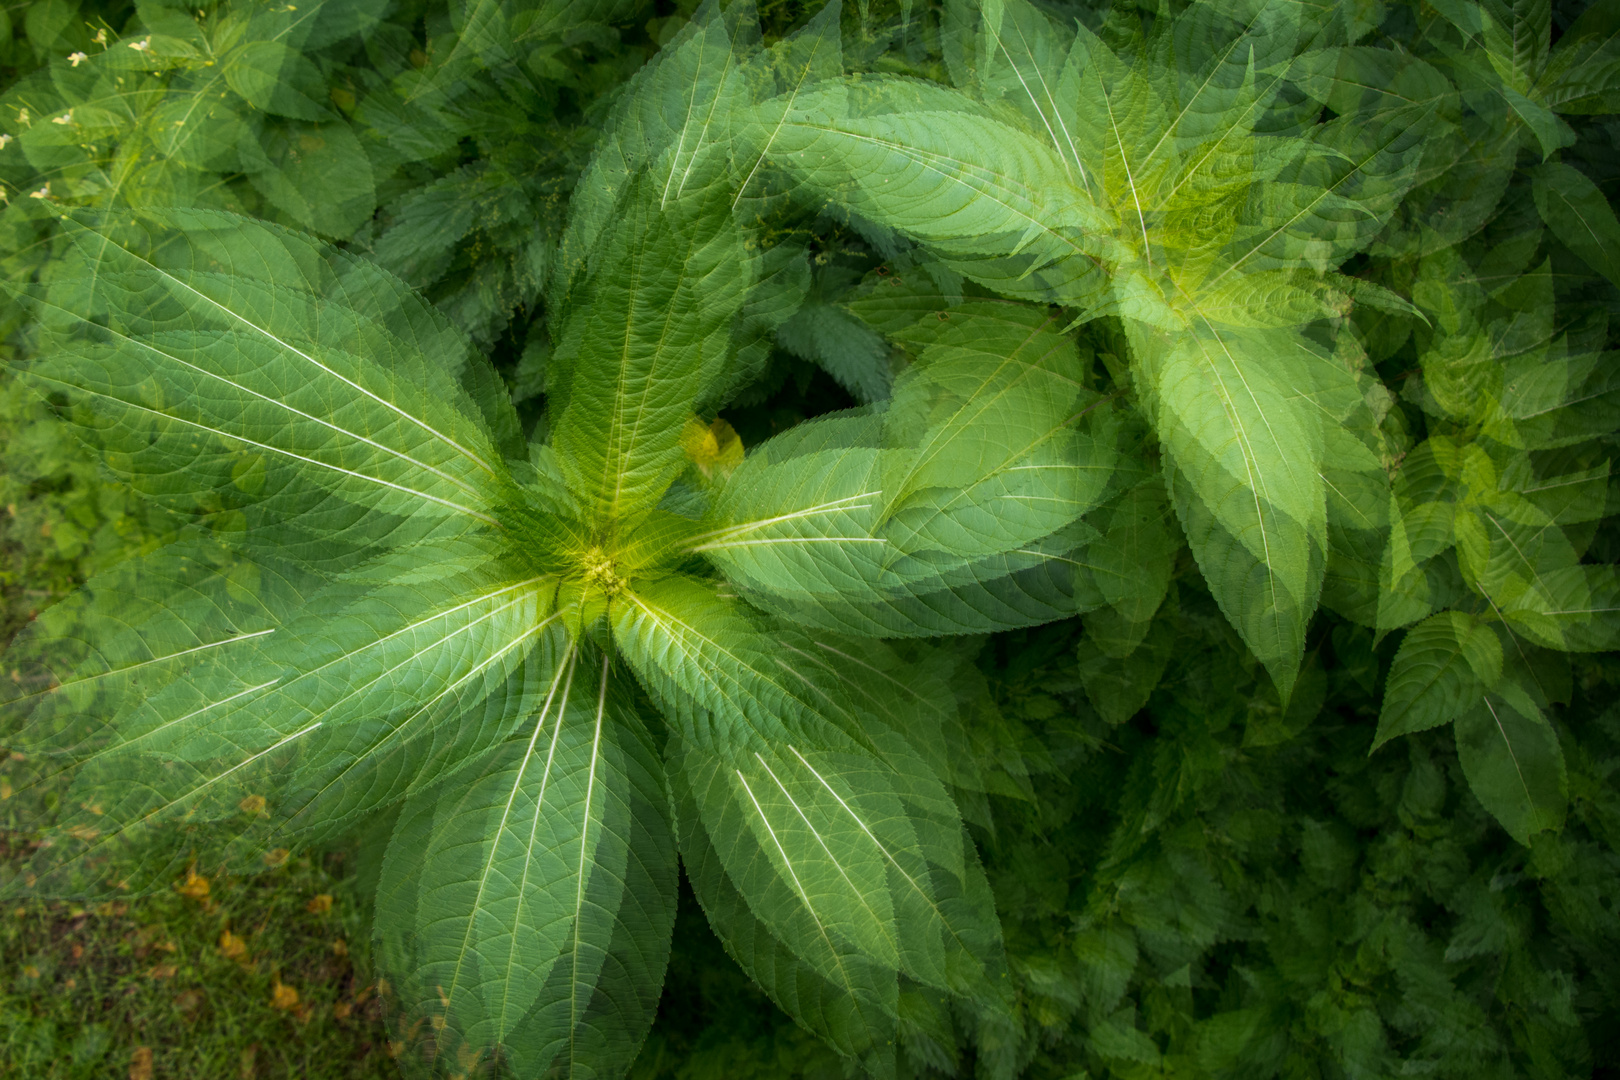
top-left (379, 653), bottom-right (674, 1075)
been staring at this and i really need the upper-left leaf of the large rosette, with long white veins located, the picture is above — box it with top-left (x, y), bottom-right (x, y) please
top-left (11, 210), bottom-right (510, 523)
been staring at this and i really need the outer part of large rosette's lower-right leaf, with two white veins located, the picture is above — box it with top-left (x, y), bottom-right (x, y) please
top-left (679, 721), bottom-right (1000, 997)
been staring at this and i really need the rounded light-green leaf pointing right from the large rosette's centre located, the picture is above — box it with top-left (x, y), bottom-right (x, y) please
top-left (693, 303), bottom-right (1113, 633)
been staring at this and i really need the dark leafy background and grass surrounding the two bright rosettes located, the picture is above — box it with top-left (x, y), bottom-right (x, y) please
top-left (0, 0), bottom-right (1620, 1080)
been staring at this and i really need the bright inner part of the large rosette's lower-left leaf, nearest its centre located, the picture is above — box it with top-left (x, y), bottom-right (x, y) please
top-left (243, 538), bottom-right (564, 836)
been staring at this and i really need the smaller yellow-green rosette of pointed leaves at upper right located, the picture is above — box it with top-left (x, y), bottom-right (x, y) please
top-left (752, 0), bottom-right (1448, 698)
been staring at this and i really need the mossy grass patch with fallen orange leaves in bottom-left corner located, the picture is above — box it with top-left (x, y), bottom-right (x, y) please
top-left (0, 855), bottom-right (399, 1080)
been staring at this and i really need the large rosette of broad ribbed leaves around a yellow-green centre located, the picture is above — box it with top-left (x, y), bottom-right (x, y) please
top-left (6, 14), bottom-right (1113, 1075)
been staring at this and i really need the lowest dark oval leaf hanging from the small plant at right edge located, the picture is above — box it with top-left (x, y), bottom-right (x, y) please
top-left (1456, 682), bottom-right (1568, 844)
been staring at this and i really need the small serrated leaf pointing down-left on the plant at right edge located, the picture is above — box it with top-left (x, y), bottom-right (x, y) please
top-left (1369, 612), bottom-right (1502, 753)
